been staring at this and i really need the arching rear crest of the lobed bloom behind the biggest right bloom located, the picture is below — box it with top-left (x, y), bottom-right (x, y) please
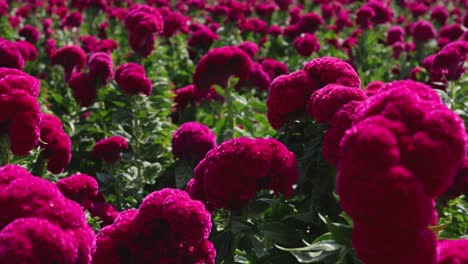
top-left (267, 57), bottom-right (361, 129)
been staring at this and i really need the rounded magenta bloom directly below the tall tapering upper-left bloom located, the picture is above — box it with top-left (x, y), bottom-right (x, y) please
top-left (115, 62), bottom-right (153, 96)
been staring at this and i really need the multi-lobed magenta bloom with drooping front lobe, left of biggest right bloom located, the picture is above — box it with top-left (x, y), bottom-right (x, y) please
top-left (267, 57), bottom-right (367, 164)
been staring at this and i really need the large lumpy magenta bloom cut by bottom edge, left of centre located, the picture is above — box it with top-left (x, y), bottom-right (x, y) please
top-left (92, 188), bottom-right (216, 264)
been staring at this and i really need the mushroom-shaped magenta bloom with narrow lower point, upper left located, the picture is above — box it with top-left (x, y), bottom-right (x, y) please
top-left (51, 45), bottom-right (87, 81)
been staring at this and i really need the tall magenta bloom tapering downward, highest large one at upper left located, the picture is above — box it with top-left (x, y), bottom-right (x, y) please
top-left (125, 4), bottom-right (164, 58)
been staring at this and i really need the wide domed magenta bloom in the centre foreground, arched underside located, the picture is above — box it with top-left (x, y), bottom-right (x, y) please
top-left (187, 138), bottom-right (299, 210)
